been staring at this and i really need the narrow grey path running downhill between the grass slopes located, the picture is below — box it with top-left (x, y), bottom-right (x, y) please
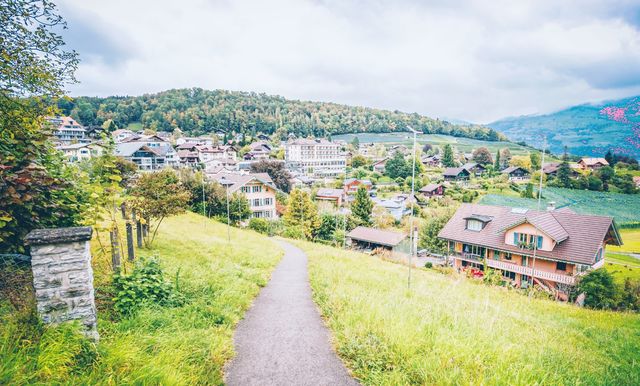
top-left (225, 241), bottom-right (358, 386)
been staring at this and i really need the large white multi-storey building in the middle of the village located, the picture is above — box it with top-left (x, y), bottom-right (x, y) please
top-left (285, 139), bottom-right (347, 177)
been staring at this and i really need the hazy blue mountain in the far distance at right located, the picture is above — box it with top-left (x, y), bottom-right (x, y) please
top-left (487, 96), bottom-right (640, 158)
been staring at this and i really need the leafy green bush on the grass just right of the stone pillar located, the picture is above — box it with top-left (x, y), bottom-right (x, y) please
top-left (113, 259), bottom-right (180, 315)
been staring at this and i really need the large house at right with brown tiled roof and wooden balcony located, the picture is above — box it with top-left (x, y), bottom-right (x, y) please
top-left (438, 204), bottom-right (622, 299)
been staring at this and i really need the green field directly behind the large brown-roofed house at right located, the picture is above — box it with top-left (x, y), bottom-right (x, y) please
top-left (480, 188), bottom-right (640, 225)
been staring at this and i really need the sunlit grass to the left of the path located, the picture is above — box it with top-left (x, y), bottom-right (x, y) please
top-left (0, 214), bottom-right (282, 385)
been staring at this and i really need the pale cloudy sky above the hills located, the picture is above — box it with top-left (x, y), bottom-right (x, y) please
top-left (58, 0), bottom-right (640, 123)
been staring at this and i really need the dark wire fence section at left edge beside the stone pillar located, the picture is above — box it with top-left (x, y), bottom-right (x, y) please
top-left (0, 254), bottom-right (35, 310)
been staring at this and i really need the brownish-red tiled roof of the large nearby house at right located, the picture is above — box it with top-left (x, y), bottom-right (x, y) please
top-left (438, 204), bottom-right (622, 265)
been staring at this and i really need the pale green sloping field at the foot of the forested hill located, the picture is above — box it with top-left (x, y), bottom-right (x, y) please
top-left (333, 133), bottom-right (531, 155)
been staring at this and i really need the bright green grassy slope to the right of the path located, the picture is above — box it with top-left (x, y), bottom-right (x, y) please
top-left (297, 242), bottom-right (640, 385)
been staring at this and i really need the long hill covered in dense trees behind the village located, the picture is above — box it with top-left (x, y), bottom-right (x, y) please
top-left (59, 88), bottom-right (505, 141)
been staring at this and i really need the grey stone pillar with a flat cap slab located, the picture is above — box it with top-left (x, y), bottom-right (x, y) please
top-left (26, 227), bottom-right (98, 340)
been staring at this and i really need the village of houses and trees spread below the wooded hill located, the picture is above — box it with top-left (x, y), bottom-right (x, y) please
top-left (50, 117), bottom-right (640, 301)
